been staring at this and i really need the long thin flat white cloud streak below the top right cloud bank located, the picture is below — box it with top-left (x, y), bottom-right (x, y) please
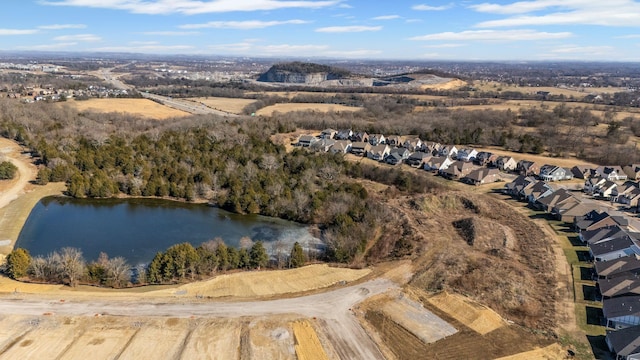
top-left (409, 30), bottom-right (573, 41)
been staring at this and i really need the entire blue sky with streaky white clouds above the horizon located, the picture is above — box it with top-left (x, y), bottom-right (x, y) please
top-left (0, 0), bottom-right (640, 61)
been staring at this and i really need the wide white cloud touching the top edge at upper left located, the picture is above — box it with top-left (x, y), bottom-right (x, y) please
top-left (40, 0), bottom-right (343, 15)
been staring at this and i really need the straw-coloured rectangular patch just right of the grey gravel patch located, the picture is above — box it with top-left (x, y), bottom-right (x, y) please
top-left (427, 292), bottom-right (506, 335)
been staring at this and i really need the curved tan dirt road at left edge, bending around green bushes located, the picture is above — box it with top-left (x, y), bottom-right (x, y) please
top-left (0, 138), bottom-right (36, 208)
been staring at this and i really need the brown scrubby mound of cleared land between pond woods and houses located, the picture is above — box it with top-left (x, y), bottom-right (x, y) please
top-left (388, 191), bottom-right (555, 332)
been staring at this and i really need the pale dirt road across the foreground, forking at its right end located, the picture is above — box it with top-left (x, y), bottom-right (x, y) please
top-left (0, 278), bottom-right (399, 359)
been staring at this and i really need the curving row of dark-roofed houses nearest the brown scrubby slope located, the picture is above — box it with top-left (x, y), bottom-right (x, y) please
top-left (504, 175), bottom-right (640, 359)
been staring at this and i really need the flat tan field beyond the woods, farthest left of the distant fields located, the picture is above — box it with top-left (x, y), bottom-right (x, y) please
top-left (60, 99), bottom-right (191, 120)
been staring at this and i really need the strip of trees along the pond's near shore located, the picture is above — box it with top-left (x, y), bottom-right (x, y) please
top-left (3, 239), bottom-right (307, 288)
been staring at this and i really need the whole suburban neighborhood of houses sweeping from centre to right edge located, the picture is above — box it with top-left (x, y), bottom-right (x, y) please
top-left (293, 129), bottom-right (640, 359)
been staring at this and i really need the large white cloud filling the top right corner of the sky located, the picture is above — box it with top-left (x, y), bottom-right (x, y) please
top-left (470, 0), bottom-right (640, 28)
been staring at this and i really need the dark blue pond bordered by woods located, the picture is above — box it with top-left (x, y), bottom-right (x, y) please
top-left (16, 197), bottom-right (322, 265)
